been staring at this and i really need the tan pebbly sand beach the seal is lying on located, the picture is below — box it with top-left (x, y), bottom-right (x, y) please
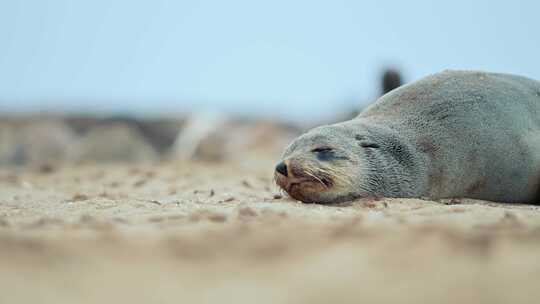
top-left (0, 159), bottom-right (540, 303)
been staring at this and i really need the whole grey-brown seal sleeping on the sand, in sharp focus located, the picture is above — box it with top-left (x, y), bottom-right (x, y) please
top-left (275, 71), bottom-right (540, 203)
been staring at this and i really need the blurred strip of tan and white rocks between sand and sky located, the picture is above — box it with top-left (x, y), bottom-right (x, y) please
top-left (0, 113), bottom-right (300, 166)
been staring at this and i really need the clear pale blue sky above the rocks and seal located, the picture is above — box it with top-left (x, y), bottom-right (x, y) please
top-left (0, 0), bottom-right (540, 118)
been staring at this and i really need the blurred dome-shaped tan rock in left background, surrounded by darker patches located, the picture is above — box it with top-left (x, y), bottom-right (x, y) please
top-left (70, 123), bottom-right (159, 162)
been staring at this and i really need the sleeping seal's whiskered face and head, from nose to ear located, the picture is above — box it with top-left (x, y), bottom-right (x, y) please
top-left (275, 125), bottom-right (376, 203)
